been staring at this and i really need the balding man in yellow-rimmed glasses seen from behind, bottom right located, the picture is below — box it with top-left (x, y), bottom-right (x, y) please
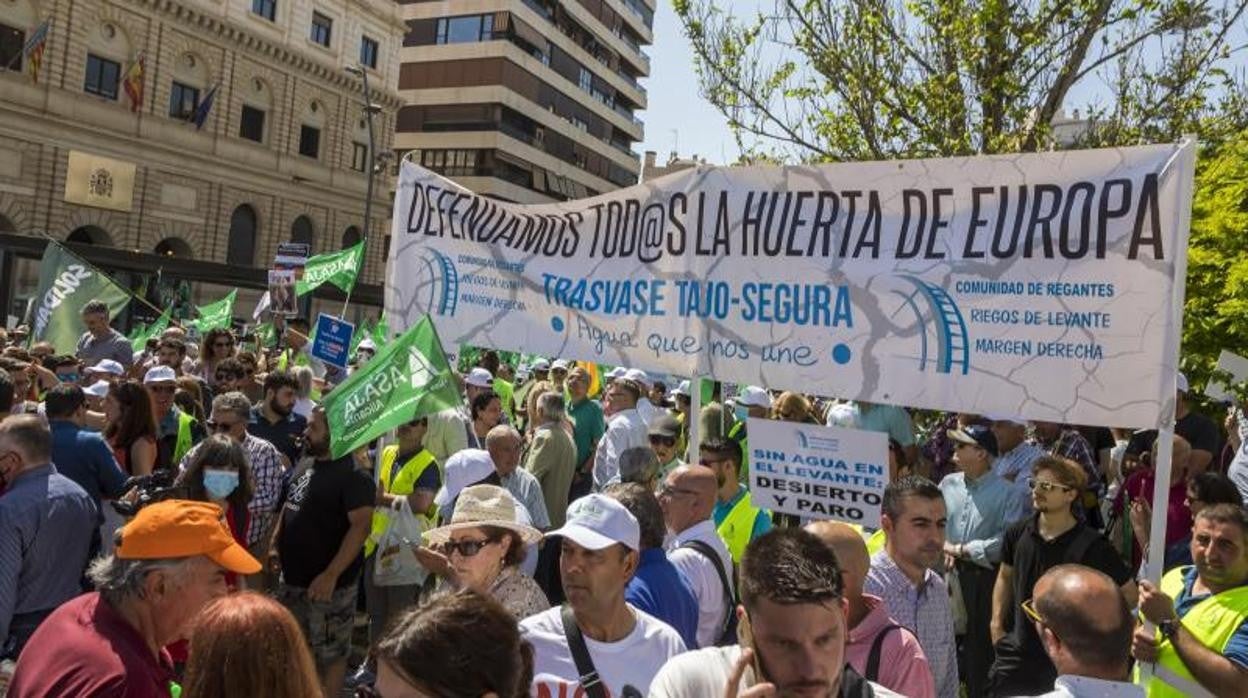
top-left (1023, 564), bottom-right (1144, 698)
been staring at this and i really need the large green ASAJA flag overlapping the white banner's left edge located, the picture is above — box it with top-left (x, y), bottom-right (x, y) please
top-left (324, 316), bottom-right (461, 458)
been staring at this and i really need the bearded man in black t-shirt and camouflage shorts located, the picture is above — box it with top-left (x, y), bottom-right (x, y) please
top-left (277, 407), bottom-right (377, 696)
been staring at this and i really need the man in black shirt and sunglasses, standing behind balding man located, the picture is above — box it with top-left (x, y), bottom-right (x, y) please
top-left (988, 456), bottom-right (1136, 697)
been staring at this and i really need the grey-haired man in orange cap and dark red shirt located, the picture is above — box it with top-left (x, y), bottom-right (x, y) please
top-left (9, 499), bottom-right (260, 698)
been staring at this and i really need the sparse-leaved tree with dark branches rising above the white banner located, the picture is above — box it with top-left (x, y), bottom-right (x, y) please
top-left (674, 0), bottom-right (1248, 161)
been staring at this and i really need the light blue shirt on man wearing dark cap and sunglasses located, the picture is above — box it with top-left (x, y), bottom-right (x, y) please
top-left (940, 471), bottom-right (1027, 568)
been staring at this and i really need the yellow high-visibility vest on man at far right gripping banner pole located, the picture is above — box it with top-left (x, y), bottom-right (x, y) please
top-left (1136, 567), bottom-right (1248, 698)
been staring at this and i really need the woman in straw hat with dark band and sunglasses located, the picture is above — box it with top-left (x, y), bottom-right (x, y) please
top-left (417, 484), bottom-right (550, 619)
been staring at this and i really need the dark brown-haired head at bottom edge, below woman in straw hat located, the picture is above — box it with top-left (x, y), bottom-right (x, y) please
top-left (356, 589), bottom-right (533, 698)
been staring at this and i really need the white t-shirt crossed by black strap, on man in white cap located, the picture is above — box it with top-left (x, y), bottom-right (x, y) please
top-left (520, 606), bottom-right (685, 698)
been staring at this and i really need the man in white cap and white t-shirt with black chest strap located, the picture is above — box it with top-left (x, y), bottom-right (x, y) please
top-left (520, 494), bottom-right (685, 697)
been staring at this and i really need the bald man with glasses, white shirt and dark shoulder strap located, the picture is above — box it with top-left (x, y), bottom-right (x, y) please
top-left (659, 466), bottom-right (736, 647)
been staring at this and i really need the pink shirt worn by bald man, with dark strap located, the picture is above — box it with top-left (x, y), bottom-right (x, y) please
top-left (845, 594), bottom-right (936, 698)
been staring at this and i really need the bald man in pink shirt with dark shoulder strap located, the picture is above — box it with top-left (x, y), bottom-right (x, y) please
top-left (806, 521), bottom-right (936, 698)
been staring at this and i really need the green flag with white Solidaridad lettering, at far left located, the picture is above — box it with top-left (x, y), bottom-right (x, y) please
top-left (30, 241), bottom-right (130, 353)
